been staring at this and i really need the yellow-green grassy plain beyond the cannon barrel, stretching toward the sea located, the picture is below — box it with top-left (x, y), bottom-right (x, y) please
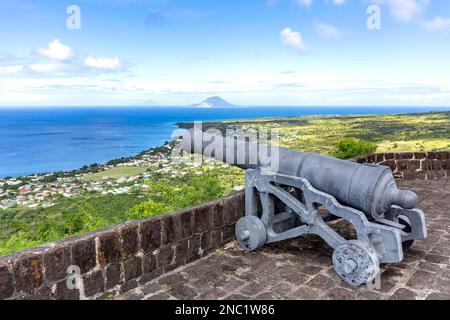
top-left (213, 112), bottom-right (450, 156)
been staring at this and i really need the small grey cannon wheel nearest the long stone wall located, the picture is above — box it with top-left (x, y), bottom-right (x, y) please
top-left (235, 216), bottom-right (267, 251)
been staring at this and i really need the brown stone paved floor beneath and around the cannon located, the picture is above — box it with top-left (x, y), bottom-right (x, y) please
top-left (115, 179), bottom-right (450, 300)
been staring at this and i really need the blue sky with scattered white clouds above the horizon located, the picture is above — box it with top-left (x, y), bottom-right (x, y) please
top-left (0, 0), bottom-right (450, 106)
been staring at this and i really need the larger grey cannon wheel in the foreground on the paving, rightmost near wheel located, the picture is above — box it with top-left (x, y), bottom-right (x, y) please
top-left (333, 240), bottom-right (380, 287)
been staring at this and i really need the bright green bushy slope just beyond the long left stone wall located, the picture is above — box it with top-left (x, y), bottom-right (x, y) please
top-left (0, 166), bottom-right (242, 255)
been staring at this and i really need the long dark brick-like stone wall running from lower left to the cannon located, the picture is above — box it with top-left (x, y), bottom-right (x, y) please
top-left (0, 193), bottom-right (244, 299)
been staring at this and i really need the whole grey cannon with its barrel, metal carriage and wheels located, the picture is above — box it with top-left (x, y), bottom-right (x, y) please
top-left (183, 129), bottom-right (427, 286)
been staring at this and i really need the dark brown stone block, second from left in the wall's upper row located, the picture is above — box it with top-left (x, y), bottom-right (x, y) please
top-left (14, 255), bottom-right (43, 292)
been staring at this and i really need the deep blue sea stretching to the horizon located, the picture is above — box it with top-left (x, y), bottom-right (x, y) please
top-left (0, 107), bottom-right (449, 177)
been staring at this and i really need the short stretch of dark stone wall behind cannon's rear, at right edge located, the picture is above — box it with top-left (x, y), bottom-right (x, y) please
top-left (352, 151), bottom-right (450, 180)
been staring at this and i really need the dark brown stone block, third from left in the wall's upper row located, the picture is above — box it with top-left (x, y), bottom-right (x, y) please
top-left (44, 247), bottom-right (71, 282)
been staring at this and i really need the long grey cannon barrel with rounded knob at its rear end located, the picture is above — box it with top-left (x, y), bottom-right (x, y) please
top-left (183, 128), bottom-right (417, 219)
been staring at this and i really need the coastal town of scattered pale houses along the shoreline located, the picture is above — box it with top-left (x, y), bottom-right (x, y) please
top-left (0, 141), bottom-right (195, 209)
